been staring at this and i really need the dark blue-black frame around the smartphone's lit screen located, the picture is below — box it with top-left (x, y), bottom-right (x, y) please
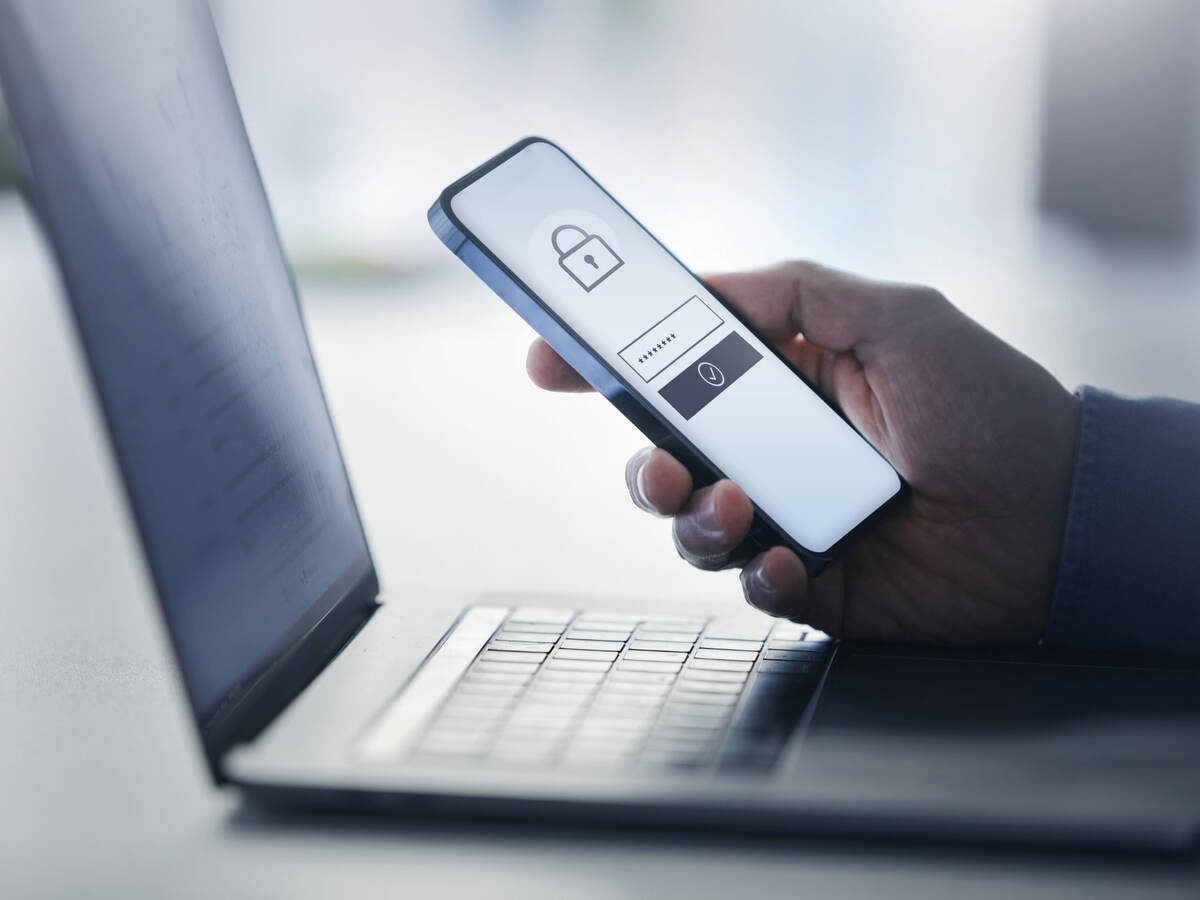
top-left (438, 136), bottom-right (910, 562)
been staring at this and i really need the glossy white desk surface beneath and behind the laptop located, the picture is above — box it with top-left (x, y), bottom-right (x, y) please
top-left (0, 203), bottom-right (1200, 898)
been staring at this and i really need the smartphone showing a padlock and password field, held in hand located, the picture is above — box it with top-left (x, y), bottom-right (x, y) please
top-left (428, 137), bottom-right (905, 575)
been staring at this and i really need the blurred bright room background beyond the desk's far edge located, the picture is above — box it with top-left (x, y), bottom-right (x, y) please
top-left (215, 0), bottom-right (1200, 396)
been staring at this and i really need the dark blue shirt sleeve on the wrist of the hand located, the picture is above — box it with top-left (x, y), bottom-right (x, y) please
top-left (1045, 388), bottom-right (1200, 653)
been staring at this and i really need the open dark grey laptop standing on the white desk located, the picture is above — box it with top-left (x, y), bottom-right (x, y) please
top-left (0, 0), bottom-right (1200, 850)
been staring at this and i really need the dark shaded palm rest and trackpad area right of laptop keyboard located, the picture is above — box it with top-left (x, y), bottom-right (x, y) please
top-left (790, 646), bottom-right (1200, 829)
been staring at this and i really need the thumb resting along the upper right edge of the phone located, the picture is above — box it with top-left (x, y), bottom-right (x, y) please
top-left (706, 262), bottom-right (898, 353)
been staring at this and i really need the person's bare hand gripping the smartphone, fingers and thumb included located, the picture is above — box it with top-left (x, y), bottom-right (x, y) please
top-left (527, 263), bottom-right (1079, 642)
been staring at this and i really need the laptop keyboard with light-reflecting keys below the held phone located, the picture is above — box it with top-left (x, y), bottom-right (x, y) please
top-left (408, 608), bottom-right (833, 772)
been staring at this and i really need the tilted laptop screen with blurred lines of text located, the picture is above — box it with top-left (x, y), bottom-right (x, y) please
top-left (0, 0), bottom-right (373, 724)
